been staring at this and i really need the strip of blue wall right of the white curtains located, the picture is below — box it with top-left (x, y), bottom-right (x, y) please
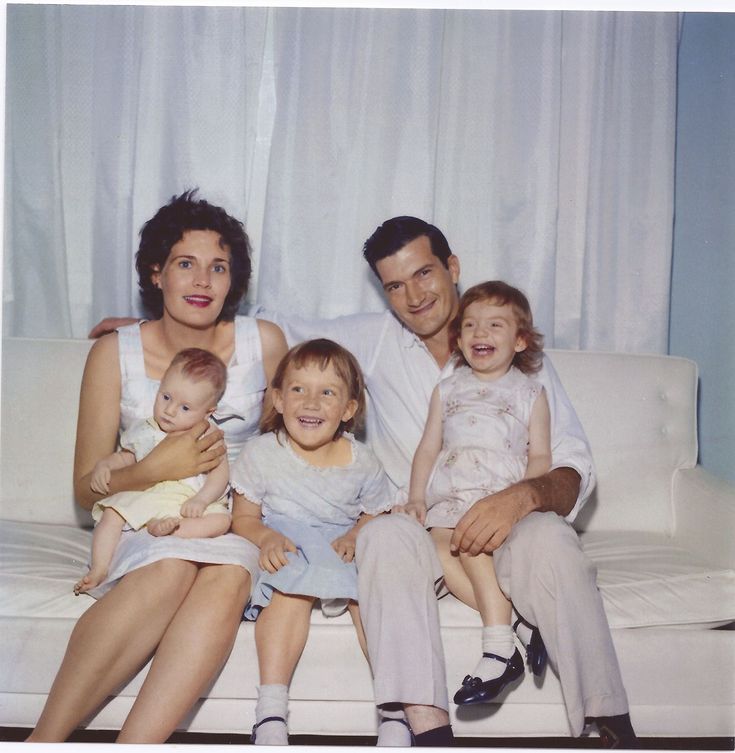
top-left (669, 13), bottom-right (735, 482)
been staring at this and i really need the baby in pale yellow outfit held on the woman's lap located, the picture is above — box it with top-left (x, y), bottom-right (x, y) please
top-left (74, 348), bottom-right (230, 595)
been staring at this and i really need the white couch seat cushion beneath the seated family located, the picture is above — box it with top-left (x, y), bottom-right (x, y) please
top-left (0, 521), bottom-right (735, 628)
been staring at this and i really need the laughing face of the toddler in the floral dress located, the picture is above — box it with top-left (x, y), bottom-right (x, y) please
top-left (457, 299), bottom-right (526, 380)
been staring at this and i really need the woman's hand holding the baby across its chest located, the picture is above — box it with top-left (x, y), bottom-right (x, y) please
top-left (139, 419), bottom-right (225, 481)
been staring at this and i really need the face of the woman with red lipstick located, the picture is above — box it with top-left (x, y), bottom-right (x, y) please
top-left (151, 230), bottom-right (231, 326)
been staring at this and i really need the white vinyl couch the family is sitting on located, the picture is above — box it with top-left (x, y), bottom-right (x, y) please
top-left (0, 339), bottom-right (735, 737)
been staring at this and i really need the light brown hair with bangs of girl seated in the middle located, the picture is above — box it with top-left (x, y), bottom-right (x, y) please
top-left (260, 338), bottom-right (365, 439)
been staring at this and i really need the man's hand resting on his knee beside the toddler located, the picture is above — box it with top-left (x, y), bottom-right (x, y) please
top-left (449, 481), bottom-right (536, 556)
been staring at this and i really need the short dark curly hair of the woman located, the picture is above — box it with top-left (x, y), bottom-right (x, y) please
top-left (135, 188), bottom-right (252, 321)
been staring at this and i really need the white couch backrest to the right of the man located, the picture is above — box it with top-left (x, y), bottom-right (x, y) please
top-left (549, 350), bottom-right (697, 534)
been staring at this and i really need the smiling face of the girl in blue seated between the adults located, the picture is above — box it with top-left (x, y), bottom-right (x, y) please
top-left (273, 362), bottom-right (357, 455)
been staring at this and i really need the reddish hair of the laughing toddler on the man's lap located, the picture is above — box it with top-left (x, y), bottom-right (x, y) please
top-left (449, 280), bottom-right (544, 374)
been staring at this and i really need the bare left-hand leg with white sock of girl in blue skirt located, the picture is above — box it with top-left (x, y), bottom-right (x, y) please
top-left (253, 591), bottom-right (314, 745)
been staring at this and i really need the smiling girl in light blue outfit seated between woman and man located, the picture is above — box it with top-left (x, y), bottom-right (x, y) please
top-left (232, 339), bottom-right (392, 745)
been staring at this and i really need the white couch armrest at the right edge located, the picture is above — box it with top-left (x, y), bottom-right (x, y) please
top-left (672, 465), bottom-right (735, 568)
